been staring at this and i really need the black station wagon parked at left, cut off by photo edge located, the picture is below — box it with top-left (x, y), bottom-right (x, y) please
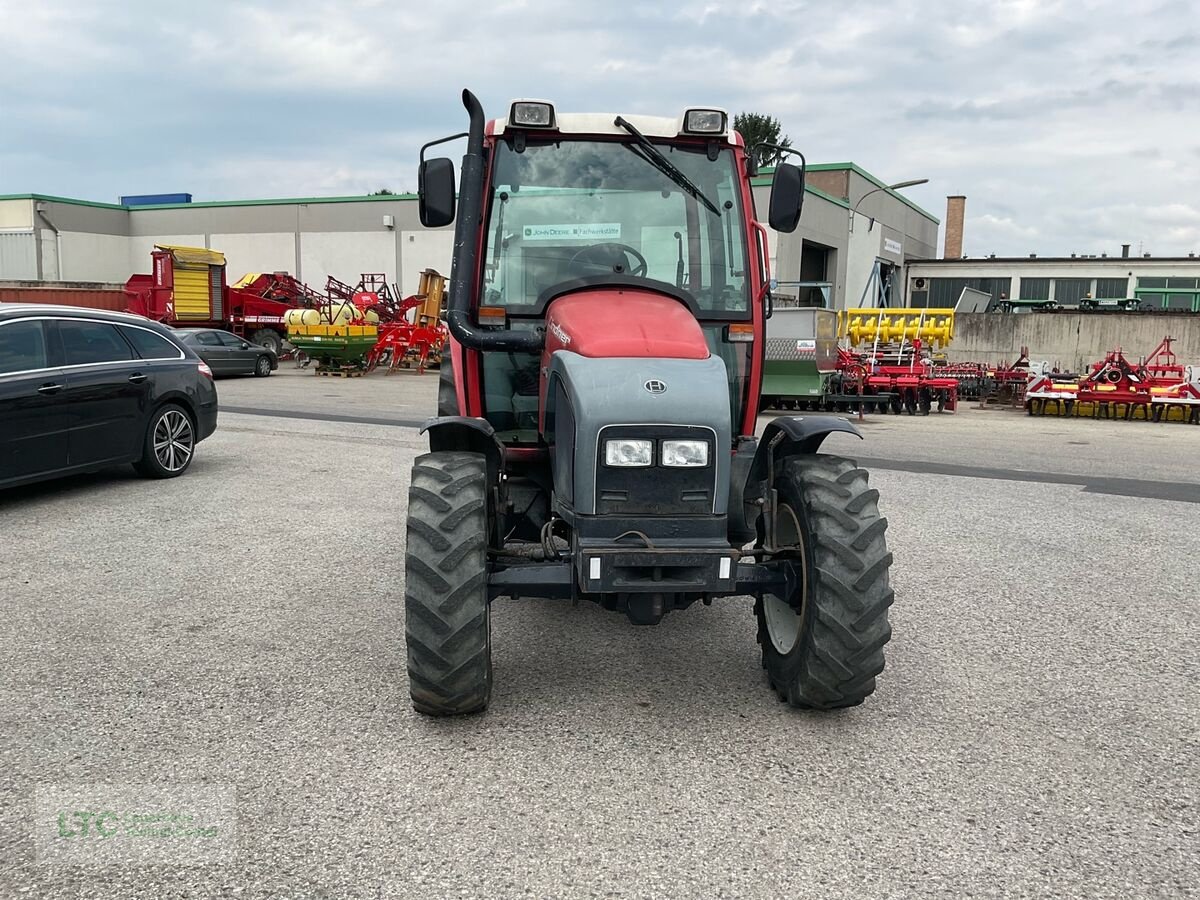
top-left (0, 304), bottom-right (217, 487)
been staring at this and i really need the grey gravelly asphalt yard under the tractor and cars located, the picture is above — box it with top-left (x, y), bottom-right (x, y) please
top-left (0, 364), bottom-right (1200, 898)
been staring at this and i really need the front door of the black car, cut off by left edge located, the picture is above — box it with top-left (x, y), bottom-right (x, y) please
top-left (0, 319), bottom-right (67, 485)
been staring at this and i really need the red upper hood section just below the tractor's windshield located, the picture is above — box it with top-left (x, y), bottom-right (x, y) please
top-left (545, 287), bottom-right (709, 359)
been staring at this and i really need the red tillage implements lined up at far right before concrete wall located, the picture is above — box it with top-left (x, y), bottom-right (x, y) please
top-left (1025, 336), bottom-right (1200, 425)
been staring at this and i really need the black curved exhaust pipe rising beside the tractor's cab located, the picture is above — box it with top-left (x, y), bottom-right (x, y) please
top-left (446, 90), bottom-right (546, 353)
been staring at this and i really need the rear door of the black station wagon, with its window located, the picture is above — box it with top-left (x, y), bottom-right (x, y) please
top-left (53, 318), bottom-right (151, 467)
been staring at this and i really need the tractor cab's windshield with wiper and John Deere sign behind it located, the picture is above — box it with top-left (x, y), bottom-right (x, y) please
top-left (482, 140), bottom-right (750, 318)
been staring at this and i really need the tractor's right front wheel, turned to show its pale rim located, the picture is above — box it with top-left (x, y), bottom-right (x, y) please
top-left (755, 455), bottom-right (894, 709)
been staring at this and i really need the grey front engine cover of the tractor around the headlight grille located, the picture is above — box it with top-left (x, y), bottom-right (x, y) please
top-left (546, 350), bottom-right (733, 515)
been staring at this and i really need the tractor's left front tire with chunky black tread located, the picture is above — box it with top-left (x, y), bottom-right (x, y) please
top-left (404, 450), bottom-right (492, 715)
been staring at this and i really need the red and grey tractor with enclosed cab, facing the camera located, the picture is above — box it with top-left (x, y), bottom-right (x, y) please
top-left (406, 91), bottom-right (893, 715)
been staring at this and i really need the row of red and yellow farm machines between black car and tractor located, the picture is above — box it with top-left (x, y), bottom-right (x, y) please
top-left (125, 244), bottom-right (448, 372)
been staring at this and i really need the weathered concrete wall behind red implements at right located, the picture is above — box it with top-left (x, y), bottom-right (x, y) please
top-left (946, 313), bottom-right (1200, 372)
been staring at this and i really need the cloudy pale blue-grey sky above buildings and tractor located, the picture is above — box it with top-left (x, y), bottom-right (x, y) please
top-left (0, 0), bottom-right (1200, 256)
